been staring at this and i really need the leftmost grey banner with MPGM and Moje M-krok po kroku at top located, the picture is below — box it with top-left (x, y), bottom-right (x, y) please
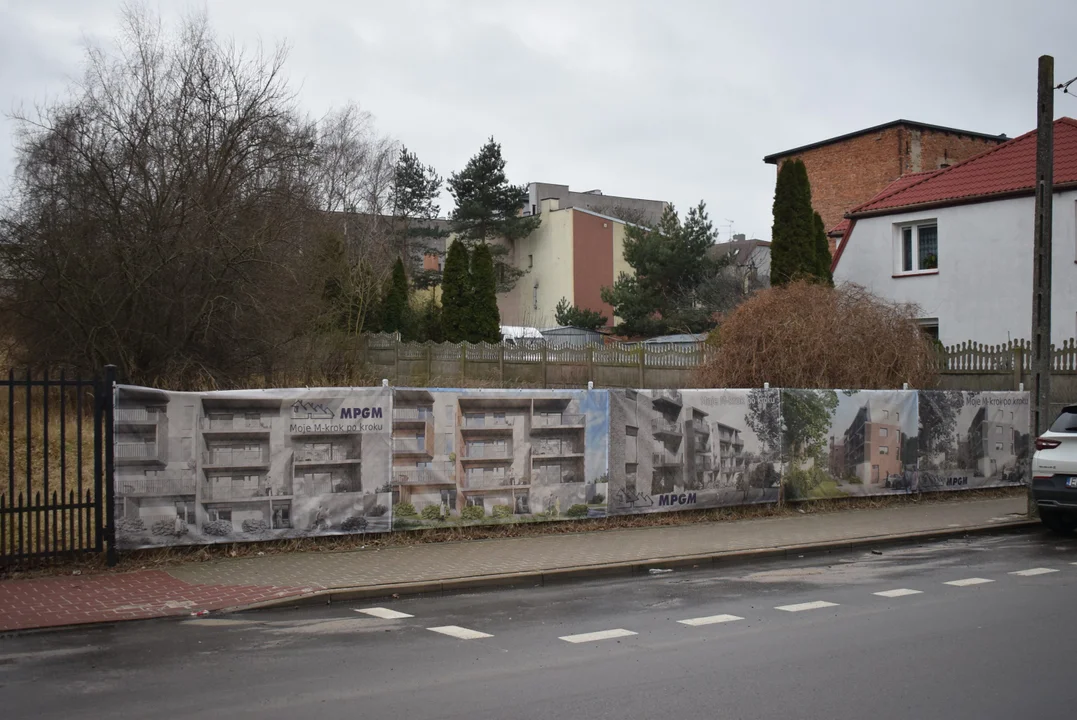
top-left (114, 385), bottom-right (392, 548)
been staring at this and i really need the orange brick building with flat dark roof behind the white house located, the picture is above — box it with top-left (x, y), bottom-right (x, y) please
top-left (763, 119), bottom-right (1007, 254)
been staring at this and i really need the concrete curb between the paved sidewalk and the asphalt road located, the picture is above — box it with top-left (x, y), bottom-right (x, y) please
top-left (222, 520), bottom-right (1040, 615)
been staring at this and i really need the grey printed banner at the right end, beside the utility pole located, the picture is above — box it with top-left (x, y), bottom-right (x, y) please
top-left (918, 390), bottom-right (1032, 492)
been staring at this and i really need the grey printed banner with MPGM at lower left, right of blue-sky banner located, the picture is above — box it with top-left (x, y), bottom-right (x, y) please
top-left (609, 390), bottom-right (781, 514)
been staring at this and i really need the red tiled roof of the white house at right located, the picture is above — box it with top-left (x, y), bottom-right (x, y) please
top-left (849, 117), bottom-right (1077, 216)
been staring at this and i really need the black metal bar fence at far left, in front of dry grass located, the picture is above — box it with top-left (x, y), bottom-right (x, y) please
top-left (0, 366), bottom-right (116, 567)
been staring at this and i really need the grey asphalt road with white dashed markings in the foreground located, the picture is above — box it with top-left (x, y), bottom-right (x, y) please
top-left (0, 533), bottom-right (1077, 720)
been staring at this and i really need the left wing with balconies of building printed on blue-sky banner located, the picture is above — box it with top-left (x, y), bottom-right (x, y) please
top-left (392, 390), bottom-right (457, 509)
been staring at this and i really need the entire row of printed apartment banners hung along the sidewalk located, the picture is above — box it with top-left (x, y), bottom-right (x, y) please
top-left (114, 385), bottom-right (1030, 549)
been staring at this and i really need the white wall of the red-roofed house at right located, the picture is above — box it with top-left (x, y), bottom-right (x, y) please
top-left (835, 192), bottom-right (1077, 345)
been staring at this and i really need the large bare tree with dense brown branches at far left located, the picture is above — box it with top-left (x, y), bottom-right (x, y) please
top-left (0, 8), bottom-right (317, 380)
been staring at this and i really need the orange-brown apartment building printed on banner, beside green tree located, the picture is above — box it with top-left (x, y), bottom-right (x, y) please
top-left (830, 403), bottom-right (905, 484)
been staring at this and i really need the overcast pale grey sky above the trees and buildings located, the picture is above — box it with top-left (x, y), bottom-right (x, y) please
top-left (0, 0), bottom-right (1077, 238)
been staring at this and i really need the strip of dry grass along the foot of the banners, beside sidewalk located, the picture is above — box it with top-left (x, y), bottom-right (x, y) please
top-left (0, 488), bottom-right (1025, 579)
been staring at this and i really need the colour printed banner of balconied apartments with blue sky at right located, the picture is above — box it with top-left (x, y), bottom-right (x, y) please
top-left (392, 389), bottom-right (609, 528)
